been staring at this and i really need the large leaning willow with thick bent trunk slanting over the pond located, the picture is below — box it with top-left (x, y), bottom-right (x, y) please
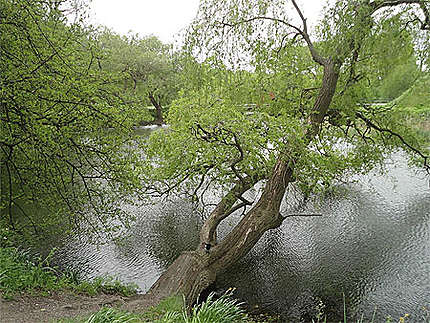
top-left (132, 0), bottom-right (430, 312)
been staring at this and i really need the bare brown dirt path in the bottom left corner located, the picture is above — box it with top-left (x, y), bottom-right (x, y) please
top-left (0, 292), bottom-right (138, 323)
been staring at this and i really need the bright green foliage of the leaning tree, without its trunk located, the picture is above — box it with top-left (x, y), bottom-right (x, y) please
top-left (139, 0), bottom-right (426, 205)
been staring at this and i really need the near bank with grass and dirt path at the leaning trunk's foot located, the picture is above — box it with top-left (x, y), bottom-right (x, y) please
top-left (0, 239), bottom-right (276, 323)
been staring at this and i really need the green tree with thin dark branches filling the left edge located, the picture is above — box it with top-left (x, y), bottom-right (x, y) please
top-left (0, 0), bottom-right (139, 238)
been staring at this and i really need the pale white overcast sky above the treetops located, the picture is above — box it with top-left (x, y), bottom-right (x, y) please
top-left (91, 0), bottom-right (326, 43)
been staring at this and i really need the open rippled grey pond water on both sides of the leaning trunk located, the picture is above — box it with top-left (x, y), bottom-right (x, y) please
top-left (49, 155), bottom-right (430, 322)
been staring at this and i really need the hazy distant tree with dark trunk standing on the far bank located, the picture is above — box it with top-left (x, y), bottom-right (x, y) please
top-left (98, 30), bottom-right (180, 125)
